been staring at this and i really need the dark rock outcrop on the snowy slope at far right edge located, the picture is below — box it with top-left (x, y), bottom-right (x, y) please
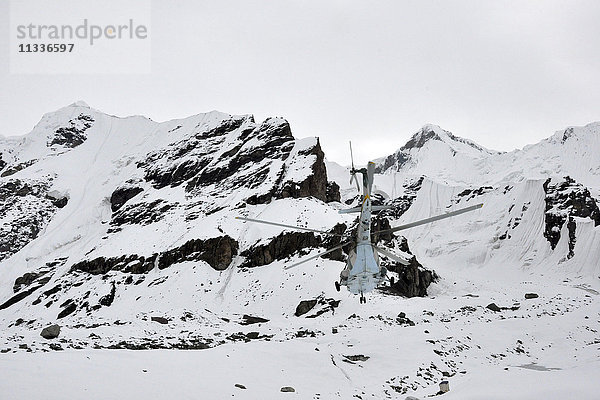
top-left (544, 176), bottom-right (600, 258)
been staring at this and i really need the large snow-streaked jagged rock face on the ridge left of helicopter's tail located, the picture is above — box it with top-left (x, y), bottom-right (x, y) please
top-left (138, 116), bottom-right (327, 204)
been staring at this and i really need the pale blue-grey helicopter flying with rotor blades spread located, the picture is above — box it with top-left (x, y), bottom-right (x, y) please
top-left (236, 144), bottom-right (483, 304)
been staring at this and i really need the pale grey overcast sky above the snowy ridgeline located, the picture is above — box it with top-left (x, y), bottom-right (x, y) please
top-left (0, 0), bottom-right (600, 164)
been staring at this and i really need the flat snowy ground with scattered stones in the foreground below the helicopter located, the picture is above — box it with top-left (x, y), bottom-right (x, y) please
top-left (0, 267), bottom-right (600, 399)
